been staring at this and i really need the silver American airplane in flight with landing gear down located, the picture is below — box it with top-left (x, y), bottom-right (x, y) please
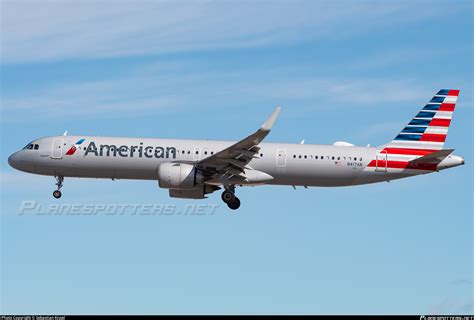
top-left (8, 89), bottom-right (464, 210)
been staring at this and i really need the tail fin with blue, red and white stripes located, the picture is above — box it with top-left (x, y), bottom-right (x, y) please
top-left (384, 89), bottom-right (459, 153)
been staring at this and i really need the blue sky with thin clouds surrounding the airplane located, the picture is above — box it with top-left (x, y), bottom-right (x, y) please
top-left (0, 0), bottom-right (474, 314)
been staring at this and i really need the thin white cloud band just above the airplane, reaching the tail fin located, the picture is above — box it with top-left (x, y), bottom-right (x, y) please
top-left (2, 64), bottom-right (433, 122)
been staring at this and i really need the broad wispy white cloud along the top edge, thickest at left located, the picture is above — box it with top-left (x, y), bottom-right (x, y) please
top-left (1, 0), bottom-right (453, 63)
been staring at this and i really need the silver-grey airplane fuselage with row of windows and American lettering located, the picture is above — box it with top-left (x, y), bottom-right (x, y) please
top-left (9, 136), bottom-right (464, 186)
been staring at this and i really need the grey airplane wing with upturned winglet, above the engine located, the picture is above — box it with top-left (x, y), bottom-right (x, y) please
top-left (196, 107), bottom-right (281, 180)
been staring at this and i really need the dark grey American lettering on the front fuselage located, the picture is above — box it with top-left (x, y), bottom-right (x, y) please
top-left (84, 141), bottom-right (176, 159)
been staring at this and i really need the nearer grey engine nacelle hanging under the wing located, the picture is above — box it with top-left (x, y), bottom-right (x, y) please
top-left (158, 162), bottom-right (204, 190)
